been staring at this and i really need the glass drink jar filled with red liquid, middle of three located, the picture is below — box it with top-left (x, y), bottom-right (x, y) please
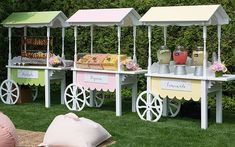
top-left (173, 46), bottom-right (188, 65)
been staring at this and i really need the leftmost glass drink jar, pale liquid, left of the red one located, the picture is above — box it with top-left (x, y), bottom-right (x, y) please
top-left (157, 45), bottom-right (171, 64)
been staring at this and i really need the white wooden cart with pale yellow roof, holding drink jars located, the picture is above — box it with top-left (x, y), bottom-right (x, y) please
top-left (136, 5), bottom-right (235, 129)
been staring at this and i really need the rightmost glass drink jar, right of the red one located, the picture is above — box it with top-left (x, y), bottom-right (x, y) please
top-left (193, 46), bottom-right (204, 66)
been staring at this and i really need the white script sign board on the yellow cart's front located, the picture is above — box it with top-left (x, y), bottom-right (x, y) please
top-left (160, 79), bottom-right (192, 91)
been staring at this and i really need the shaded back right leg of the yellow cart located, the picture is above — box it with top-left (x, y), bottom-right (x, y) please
top-left (216, 83), bottom-right (223, 123)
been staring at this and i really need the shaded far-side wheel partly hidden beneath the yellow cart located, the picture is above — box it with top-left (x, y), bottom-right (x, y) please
top-left (168, 99), bottom-right (181, 117)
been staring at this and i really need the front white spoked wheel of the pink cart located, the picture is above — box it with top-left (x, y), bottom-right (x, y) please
top-left (64, 84), bottom-right (86, 111)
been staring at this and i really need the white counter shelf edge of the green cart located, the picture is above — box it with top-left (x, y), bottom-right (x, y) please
top-left (6, 65), bottom-right (71, 70)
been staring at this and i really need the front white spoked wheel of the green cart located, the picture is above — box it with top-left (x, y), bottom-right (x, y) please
top-left (0, 80), bottom-right (20, 104)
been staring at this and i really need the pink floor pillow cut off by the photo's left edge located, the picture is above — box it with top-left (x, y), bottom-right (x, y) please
top-left (0, 112), bottom-right (18, 147)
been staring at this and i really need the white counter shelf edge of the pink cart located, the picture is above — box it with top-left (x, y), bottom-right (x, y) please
top-left (71, 68), bottom-right (147, 75)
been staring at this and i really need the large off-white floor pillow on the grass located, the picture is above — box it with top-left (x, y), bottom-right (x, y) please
top-left (39, 113), bottom-right (111, 147)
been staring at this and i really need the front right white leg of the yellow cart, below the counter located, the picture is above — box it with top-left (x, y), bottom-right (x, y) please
top-left (201, 81), bottom-right (208, 129)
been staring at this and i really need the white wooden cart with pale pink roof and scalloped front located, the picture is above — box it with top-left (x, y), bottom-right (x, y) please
top-left (64, 8), bottom-right (147, 116)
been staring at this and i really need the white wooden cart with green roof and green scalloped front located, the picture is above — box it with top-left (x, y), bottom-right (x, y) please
top-left (0, 11), bottom-right (68, 108)
